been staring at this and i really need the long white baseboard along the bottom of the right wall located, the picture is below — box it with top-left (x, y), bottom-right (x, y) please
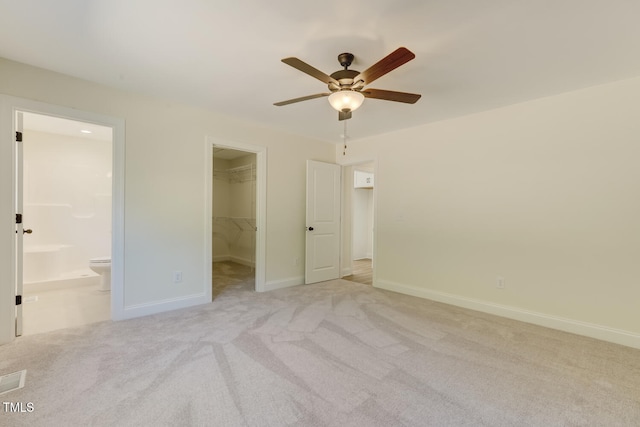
top-left (374, 280), bottom-right (640, 349)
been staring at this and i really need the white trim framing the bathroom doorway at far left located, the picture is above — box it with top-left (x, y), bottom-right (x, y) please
top-left (0, 95), bottom-right (125, 343)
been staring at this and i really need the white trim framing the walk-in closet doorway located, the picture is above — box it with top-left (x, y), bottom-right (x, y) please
top-left (203, 136), bottom-right (267, 294)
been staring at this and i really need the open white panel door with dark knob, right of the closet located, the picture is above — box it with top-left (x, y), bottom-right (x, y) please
top-left (305, 160), bottom-right (342, 284)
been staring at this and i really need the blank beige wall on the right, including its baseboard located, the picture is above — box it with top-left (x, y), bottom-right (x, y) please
top-left (336, 78), bottom-right (640, 346)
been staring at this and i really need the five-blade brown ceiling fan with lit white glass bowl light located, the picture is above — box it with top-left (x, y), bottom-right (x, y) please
top-left (273, 47), bottom-right (421, 120)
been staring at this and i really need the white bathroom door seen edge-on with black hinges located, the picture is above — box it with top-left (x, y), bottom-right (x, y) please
top-left (15, 112), bottom-right (23, 337)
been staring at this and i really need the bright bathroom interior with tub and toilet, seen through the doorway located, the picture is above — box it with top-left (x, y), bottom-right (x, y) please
top-left (16, 111), bottom-right (113, 335)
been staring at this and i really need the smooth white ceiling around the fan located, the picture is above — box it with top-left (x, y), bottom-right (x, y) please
top-left (0, 0), bottom-right (640, 143)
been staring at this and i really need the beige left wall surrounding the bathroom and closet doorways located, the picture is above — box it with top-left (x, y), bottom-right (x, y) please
top-left (0, 59), bottom-right (334, 318)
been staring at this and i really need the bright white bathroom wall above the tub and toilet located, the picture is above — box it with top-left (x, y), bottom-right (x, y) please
top-left (23, 130), bottom-right (111, 283)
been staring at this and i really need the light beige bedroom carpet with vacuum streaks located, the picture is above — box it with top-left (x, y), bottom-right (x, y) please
top-left (0, 272), bottom-right (640, 427)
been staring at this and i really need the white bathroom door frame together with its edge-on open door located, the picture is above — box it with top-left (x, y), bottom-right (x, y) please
top-left (0, 95), bottom-right (125, 344)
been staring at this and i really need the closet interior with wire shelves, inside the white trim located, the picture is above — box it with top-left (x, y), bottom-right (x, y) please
top-left (211, 145), bottom-right (257, 300)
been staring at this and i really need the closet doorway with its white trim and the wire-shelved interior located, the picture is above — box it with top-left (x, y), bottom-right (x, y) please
top-left (204, 136), bottom-right (267, 301)
